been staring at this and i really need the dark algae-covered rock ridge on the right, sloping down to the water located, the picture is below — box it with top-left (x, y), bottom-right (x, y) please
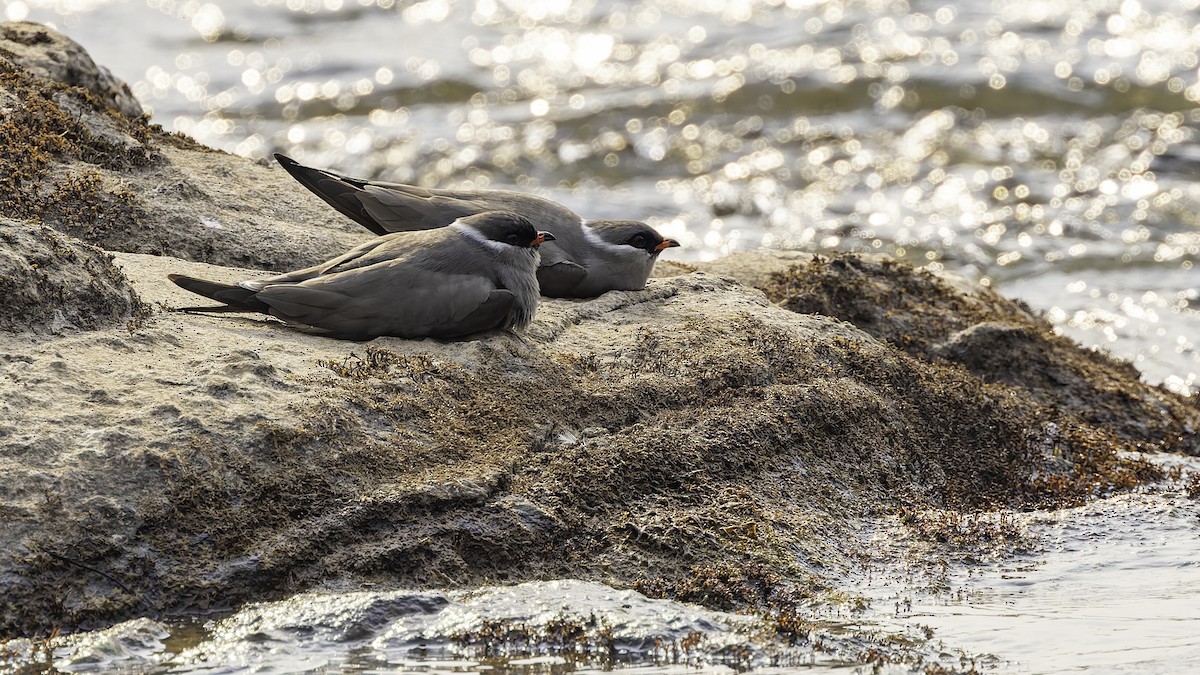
top-left (748, 253), bottom-right (1200, 455)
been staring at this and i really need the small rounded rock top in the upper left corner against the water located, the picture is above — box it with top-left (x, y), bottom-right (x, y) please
top-left (0, 22), bottom-right (143, 118)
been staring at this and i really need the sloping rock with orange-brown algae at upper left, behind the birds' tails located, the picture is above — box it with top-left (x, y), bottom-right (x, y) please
top-left (0, 23), bottom-right (368, 269)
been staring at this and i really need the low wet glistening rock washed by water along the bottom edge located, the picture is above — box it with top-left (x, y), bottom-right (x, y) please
top-left (25, 580), bottom-right (916, 675)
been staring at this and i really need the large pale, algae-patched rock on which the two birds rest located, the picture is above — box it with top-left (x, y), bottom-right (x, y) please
top-left (0, 253), bottom-right (1166, 632)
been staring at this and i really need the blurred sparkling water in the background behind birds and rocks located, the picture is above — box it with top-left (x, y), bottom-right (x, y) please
top-left (11, 0), bottom-right (1200, 392)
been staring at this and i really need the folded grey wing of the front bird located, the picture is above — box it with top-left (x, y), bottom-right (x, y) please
top-left (256, 264), bottom-right (515, 339)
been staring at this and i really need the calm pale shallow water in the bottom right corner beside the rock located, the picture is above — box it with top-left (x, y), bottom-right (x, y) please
top-left (857, 460), bottom-right (1200, 674)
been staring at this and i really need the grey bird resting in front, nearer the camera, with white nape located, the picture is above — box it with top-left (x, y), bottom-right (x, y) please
top-left (168, 211), bottom-right (554, 340)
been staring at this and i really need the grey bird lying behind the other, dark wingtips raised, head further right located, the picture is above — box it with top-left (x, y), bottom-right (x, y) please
top-left (275, 153), bottom-right (679, 298)
